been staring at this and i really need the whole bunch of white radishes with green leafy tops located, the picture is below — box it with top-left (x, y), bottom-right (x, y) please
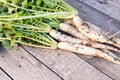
top-left (0, 0), bottom-right (120, 64)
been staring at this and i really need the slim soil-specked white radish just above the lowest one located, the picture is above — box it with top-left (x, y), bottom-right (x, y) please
top-left (49, 30), bottom-right (120, 53)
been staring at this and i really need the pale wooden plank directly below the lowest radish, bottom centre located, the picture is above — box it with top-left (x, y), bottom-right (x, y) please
top-left (23, 46), bottom-right (111, 80)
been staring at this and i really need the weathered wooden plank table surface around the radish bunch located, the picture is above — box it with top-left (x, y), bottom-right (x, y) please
top-left (0, 0), bottom-right (120, 80)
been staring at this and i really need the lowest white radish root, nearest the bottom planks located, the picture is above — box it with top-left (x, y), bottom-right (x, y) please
top-left (58, 42), bottom-right (120, 64)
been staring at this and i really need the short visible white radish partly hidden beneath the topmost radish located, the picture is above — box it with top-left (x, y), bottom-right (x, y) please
top-left (59, 23), bottom-right (88, 40)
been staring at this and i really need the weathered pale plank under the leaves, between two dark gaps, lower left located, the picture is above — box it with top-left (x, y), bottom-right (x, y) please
top-left (0, 47), bottom-right (60, 80)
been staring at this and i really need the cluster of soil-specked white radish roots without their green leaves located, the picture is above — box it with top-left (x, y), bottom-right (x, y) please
top-left (49, 16), bottom-right (120, 64)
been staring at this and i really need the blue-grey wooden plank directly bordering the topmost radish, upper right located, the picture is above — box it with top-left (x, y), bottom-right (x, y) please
top-left (66, 0), bottom-right (120, 37)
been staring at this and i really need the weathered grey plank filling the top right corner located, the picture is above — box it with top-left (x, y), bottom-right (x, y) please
top-left (80, 0), bottom-right (120, 20)
